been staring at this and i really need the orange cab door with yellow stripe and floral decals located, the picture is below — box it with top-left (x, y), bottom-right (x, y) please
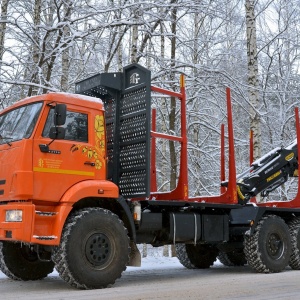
top-left (33, 105), bottom-right (104, 201)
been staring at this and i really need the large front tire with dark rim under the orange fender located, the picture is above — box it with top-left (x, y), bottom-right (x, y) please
top-left (53, 208), bottom-right (130, 289)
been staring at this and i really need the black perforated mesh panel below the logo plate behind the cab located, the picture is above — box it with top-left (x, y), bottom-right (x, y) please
top-left (119, 87), bottom-right (150, 198)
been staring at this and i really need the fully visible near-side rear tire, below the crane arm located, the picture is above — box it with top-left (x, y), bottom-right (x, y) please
top-left (244, 215), bottom-right (291, 273)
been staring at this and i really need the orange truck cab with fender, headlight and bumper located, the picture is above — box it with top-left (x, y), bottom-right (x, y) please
top-left (0, 93), bottom-right (118, 245)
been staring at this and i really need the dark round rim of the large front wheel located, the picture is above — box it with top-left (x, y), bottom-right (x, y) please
top-left (85, 233), bottom-right (112, 267)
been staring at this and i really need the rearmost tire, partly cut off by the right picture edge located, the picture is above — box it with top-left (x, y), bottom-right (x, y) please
top-left (288, 217), bottom-right (300, 270)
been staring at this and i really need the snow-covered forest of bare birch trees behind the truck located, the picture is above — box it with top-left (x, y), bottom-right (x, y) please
top-left (0, 0), bottom-right (300, 200)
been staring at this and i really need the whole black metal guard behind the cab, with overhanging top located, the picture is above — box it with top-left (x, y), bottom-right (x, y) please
top-left (75, 64), bottom-right (151, 199)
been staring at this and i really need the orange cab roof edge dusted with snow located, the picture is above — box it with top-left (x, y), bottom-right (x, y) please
top-left (1, 92), bottom-right (104, 113)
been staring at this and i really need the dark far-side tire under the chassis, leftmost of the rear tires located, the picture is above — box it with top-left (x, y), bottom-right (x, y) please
top-left (175, 244), bottom-right (218, 269)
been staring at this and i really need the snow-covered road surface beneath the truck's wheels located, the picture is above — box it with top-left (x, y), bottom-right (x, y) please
top-left (0, 257), bottom-right (300, 300)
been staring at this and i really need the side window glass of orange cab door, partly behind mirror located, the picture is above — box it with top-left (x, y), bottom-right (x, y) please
top-left (42, 109), bottom-right (88, 142)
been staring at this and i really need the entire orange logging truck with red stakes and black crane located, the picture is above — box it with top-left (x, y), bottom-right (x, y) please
top-left (0, 64), bottom-right (300, 289)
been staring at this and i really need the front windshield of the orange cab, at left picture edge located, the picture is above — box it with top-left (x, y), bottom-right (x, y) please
top-left (0, 102), bottom-right (43, 144)
